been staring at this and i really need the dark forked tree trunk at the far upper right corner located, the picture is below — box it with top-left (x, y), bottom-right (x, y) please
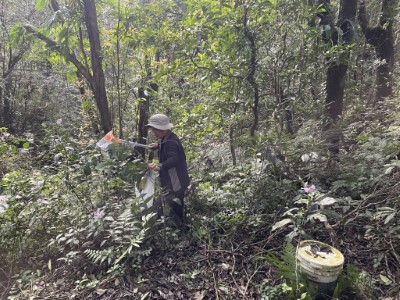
top-left (358, 0), bottom-right (399, 104)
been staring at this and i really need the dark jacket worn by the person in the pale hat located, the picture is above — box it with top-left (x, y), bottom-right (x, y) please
top-left (158, 131), bottom-right (190, 199)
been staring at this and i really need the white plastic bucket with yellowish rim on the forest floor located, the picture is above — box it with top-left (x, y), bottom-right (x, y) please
top-left (296, 240), bottom-right (344, 299)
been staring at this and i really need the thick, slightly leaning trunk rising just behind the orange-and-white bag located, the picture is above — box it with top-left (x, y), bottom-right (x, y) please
top-left (83, 0), bottom-right (112, 133)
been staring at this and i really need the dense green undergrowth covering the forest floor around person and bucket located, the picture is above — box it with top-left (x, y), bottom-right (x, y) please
top-left (0, 104), bottom-right (400, 300)
